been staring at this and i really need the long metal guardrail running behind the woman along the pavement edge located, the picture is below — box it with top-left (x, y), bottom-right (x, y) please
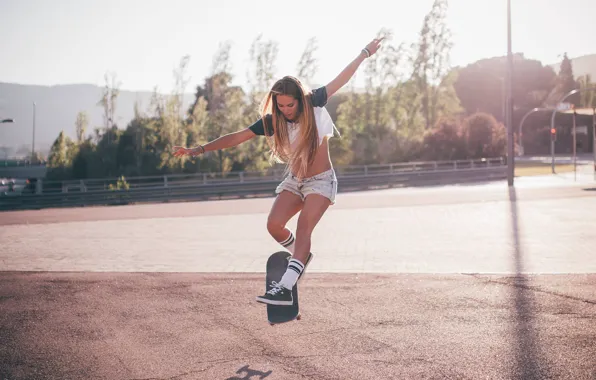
top-left (0, 158), bottom-right (506, 210)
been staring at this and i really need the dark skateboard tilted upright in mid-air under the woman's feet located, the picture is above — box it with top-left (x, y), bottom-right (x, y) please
top-left (265, 251), bottom-right (300, 325)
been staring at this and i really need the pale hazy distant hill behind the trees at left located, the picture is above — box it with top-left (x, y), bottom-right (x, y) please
top-left (0, 83), bottom-right (194, 158)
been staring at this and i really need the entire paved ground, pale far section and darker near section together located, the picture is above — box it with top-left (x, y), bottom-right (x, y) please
top-left (0, 177), bottom-right (596, 380)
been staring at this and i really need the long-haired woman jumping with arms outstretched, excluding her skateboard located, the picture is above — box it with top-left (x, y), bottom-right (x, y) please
top-left (174, 38), bottom-right (382, 305)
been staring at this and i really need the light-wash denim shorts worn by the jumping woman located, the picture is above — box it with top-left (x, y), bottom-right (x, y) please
top-left (275, 169), bottom-right (337, 205)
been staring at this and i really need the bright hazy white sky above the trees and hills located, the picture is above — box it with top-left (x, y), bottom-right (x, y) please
top-left (0, 0), bottom-right (596, 92)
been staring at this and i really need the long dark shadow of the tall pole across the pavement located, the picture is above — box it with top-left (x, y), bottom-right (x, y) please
top-left (509, 186), bottom-right (549, 380)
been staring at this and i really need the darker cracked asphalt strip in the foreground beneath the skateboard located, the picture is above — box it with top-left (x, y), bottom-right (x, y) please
top-left (0, 273), bottom-right (596, 380)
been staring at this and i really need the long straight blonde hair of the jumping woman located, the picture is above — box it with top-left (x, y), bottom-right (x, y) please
top-left (261, 76), bottom-right (319, 177)
